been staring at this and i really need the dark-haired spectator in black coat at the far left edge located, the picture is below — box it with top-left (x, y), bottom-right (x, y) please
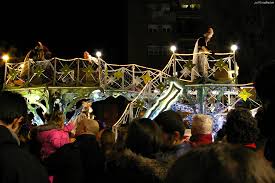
top-left (0, 91), bottom-right (48, 183)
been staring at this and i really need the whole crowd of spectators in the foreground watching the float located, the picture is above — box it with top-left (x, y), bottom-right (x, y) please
top-left (0, 61), bottom-right (275, 183)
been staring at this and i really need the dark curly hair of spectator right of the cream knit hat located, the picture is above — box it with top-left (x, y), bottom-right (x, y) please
top-left (224, 108), bottom-right (259, 144)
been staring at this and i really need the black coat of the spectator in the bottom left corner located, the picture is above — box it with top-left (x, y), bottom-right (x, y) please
top-left (0, 125), bottom-right (48, 183)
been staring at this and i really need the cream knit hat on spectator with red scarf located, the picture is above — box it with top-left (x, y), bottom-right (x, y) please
top-left (191, 114), bottom-right (213, 135)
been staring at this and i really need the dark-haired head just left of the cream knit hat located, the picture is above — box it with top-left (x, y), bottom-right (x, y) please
top-left (155, 110), bottom-right (185, 136)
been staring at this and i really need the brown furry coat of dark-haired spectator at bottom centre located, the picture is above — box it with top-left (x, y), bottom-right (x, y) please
top-left (106, 149), bottom-right (171, 183)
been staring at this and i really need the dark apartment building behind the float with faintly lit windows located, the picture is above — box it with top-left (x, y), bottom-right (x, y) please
top-left (128, 0), bottom-right (202, 69)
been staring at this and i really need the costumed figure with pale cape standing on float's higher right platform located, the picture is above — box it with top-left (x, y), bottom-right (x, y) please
top-left (191, 27), bottom-right (214, 82)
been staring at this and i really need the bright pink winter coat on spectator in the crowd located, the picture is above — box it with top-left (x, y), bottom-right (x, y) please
top-left (37, 123), bottom-right (74, 160)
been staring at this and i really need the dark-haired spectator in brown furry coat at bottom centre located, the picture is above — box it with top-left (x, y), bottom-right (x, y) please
top-left (106, 118), bottom-right (169, 183)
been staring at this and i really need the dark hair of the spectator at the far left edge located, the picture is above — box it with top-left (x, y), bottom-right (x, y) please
top-left (0, 91), bottom-right (28, 125)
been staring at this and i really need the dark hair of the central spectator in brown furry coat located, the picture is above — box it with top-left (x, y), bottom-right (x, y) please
top-left (126, 118), bottom-right (162, 157)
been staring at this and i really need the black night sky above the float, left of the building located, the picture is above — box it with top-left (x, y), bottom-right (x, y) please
top-left (0, 0), bottom-right (127, 63)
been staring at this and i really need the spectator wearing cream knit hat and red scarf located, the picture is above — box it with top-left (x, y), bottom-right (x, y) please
top-left (190, 114), bottom-right (213, 147)
